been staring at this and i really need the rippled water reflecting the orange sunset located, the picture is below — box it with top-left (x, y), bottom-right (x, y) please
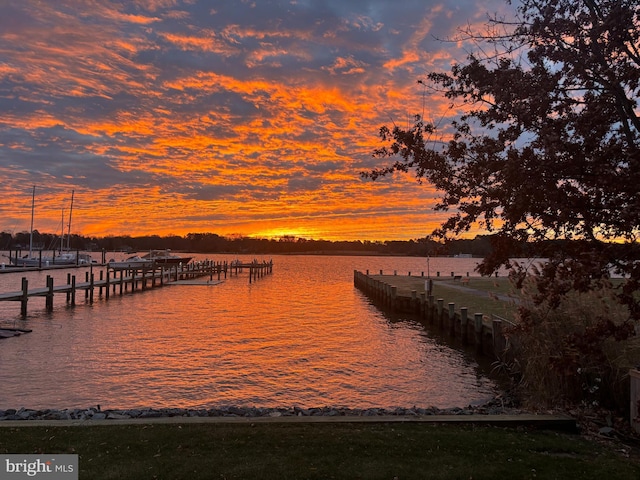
top-left (0, 256), bottom-right (510, 408)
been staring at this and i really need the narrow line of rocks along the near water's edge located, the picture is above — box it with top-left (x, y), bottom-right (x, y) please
top-left (0, 400), bottom-right (522, 422)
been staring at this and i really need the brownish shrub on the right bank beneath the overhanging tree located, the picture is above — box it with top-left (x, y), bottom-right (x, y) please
top-left (508, 269), bottom-right (640, 415)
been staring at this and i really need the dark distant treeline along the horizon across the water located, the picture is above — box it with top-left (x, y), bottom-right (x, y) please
top-left (0, 230), bottom-right (624, 257)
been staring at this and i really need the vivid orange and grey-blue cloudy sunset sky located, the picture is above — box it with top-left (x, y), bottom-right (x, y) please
top-left (0, 0), bottom-right (513, 240)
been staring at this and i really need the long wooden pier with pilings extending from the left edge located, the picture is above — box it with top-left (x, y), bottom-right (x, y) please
top-left (0, 260), bottom-right (273, 316)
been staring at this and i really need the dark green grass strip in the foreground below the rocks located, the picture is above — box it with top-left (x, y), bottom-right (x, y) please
top-left (0, 423), bottom-right (640, 480)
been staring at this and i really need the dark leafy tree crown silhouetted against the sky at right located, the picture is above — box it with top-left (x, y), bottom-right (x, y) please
top-left (363, 0), bottom-right (640, 284)
